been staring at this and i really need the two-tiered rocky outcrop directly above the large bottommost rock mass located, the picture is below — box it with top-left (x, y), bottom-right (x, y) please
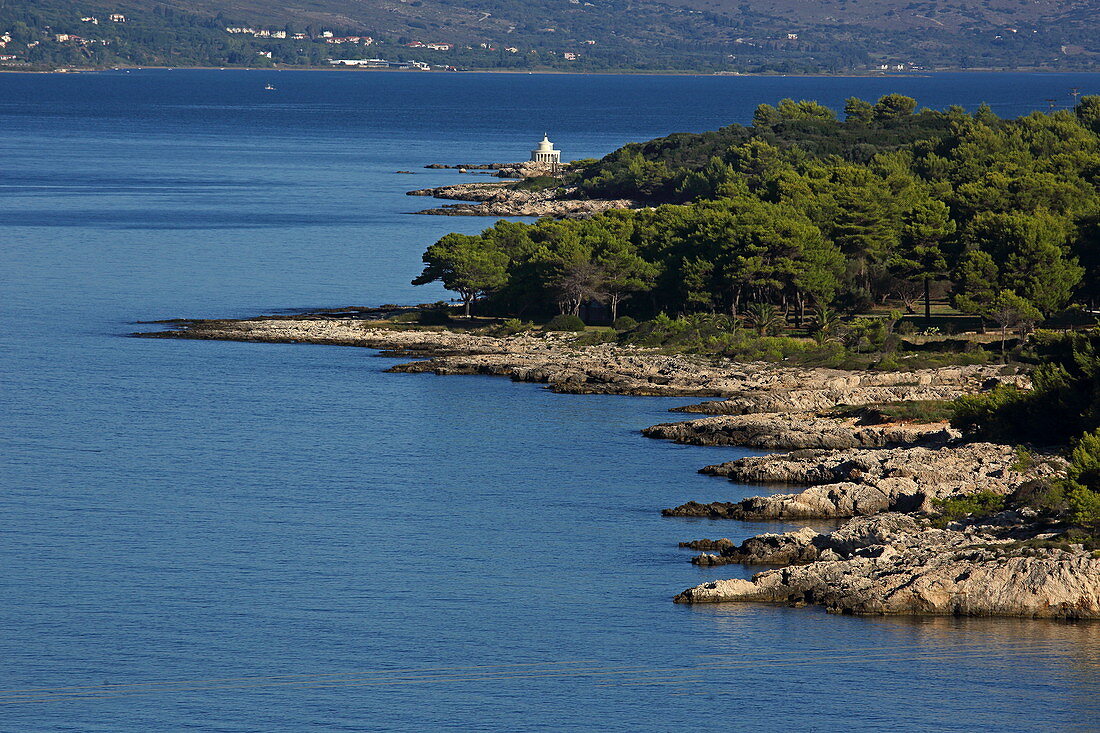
top-left (663, 442), bottom-right (1065, 519)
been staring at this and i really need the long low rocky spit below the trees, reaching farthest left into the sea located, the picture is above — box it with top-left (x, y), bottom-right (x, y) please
top-left (141, 308), bottom-right (1016, 396)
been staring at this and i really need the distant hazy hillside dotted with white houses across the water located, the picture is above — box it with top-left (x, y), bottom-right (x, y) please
top-left (0, 0), bottom-right (1100, 73)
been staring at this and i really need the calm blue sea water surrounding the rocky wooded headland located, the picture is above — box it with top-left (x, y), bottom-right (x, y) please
top-left (0, 70), bottom-right (1100, 732)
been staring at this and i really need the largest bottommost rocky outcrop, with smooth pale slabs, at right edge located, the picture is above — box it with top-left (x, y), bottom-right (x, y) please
top-left (674, 508), bottom-right (1100, 619)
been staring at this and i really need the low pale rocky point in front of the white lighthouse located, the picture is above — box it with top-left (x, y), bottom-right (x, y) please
top-left (407, 182), bottom-right (637, 217)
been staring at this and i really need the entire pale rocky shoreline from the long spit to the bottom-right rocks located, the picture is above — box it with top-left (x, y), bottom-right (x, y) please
top-left (135, 311), bottom-right (1100, 619)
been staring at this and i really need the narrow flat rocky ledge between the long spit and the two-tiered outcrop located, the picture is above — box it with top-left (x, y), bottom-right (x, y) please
top-left (642, 413), bottom-right (958, 449)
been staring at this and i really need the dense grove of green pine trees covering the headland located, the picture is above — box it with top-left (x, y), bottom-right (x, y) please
top-left (416, 95), bottom-right (1100, 327)
